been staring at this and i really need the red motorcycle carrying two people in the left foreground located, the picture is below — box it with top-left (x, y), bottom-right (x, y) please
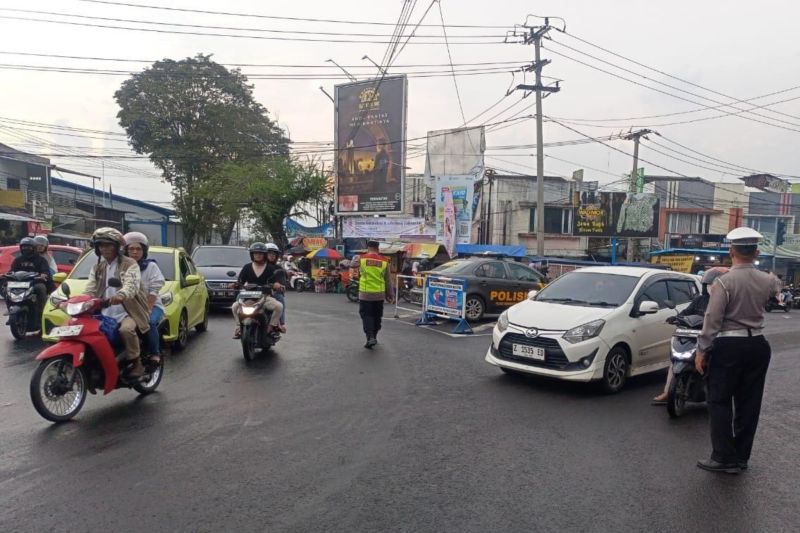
top-left (30, 278), bottom-right (164, 422)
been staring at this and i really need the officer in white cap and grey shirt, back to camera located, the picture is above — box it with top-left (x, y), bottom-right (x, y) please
top-left (695, 228), bottom-right (775, 474)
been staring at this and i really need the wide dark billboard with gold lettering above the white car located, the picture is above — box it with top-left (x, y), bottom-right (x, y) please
top-left (573, 192), bottom-right (659, 237)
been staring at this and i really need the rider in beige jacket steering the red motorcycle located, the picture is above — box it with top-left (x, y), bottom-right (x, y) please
top-left (84, 228), bottom-right (150, 377)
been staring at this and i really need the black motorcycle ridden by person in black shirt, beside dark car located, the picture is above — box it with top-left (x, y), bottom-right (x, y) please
top-left (236, 284), bottom-right (281, 361)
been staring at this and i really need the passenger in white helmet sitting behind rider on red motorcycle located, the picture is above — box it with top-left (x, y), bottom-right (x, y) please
top-left (125, 231), bottom-right (166, 363)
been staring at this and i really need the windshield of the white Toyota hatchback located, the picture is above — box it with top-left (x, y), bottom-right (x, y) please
top-left (536, 271), bottom-right (639, 307)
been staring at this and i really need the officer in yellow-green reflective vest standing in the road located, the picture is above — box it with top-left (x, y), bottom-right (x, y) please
top-left (358, 241), bottom-right (394, 350)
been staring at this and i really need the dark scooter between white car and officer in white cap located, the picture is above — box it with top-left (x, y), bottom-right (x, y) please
top-left (667, 315), bottom-right (706, 418)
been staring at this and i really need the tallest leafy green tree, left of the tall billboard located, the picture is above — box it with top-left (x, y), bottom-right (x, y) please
top-left (114, 54), bottom-right (289, 249)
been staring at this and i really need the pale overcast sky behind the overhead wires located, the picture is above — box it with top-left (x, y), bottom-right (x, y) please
top-left (0, 0), bottom-right (800, 202)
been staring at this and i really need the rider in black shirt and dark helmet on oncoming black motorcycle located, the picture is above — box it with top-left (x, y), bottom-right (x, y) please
top-left (232, 242), bottom-right (286, 339)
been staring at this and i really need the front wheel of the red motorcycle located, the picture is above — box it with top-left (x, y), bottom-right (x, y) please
top-left (30, 356), bottom-right (86, 422)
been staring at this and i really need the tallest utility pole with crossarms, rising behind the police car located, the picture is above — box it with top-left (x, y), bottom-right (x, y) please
top-left (515, 17), bottom-right (561, 257)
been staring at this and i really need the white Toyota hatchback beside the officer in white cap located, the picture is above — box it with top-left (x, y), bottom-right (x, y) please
top-left (486, 266), bottom-right (700, 392)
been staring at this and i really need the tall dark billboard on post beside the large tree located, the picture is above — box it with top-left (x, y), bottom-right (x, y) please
top-left (334, 76), bottom-right (408, 215)
